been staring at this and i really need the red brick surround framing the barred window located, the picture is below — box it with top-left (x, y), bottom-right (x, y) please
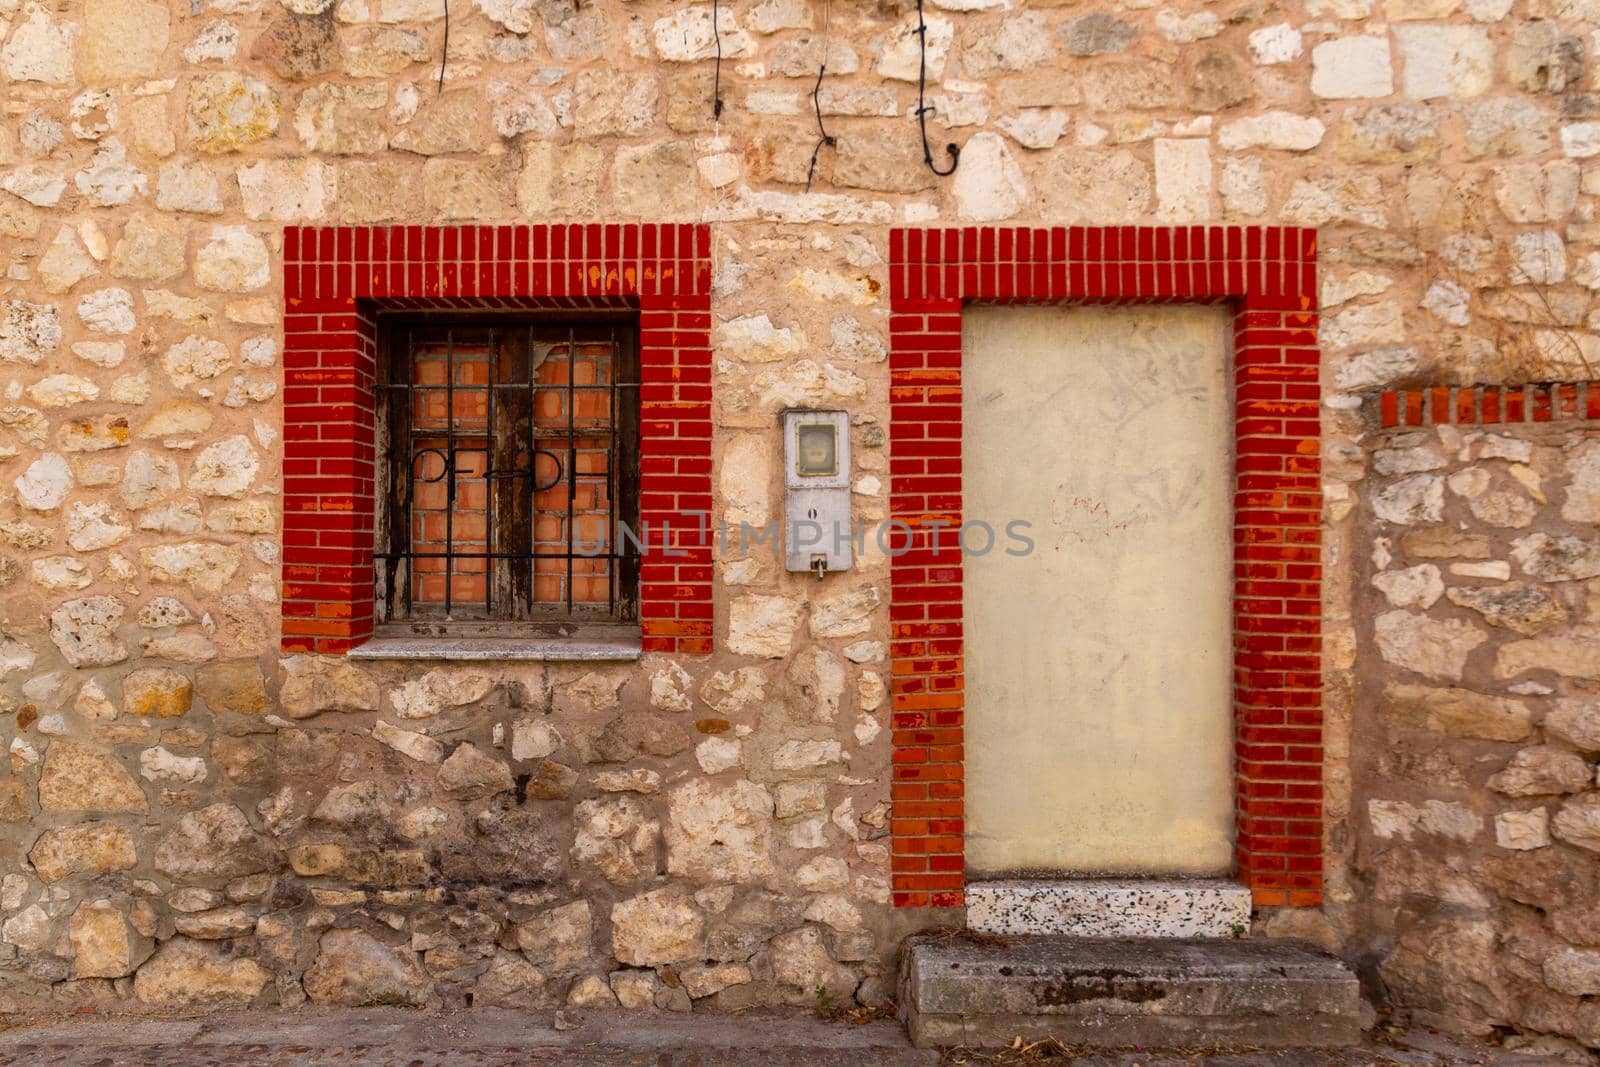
top-left (282, 224), bottom-right (712, 654)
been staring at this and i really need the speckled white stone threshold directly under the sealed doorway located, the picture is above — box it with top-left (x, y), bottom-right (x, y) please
top-left (966, 878), bottom-right (1250, 937)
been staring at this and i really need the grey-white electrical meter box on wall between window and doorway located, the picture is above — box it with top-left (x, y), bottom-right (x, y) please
top-left (782, 411), bottom-right (854, 577)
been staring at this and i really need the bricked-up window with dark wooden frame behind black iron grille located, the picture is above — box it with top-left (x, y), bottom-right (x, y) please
top-left (374, 317), bottom-right (638, 637)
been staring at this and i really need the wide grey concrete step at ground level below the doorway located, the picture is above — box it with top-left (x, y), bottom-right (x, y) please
top-left (901, 934), bottom-right (1362, 1048)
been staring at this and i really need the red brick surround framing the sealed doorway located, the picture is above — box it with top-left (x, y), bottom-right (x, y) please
top-left (890, 226), bottom-right (1323, 907)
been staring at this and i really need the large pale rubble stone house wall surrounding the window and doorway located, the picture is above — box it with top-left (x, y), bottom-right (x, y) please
top-left (0, 0), bottom-right (1600, 1027)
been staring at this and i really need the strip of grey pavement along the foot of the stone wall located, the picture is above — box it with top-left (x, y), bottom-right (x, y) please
top-left (0, 1008), bottom-right (1581, 1067)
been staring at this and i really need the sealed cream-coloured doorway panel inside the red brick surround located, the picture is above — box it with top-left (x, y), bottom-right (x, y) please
top-left (962, 307), bottom-right (1234, 878)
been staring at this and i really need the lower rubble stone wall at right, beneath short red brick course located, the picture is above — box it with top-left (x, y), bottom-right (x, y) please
top-left (1352, 426), bottom-right (1600, 1045)
